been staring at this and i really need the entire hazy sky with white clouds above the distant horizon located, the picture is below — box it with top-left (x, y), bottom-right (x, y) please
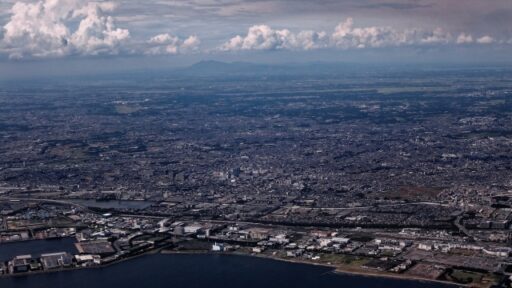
top-left (0, 0), bottom-right (512, 76)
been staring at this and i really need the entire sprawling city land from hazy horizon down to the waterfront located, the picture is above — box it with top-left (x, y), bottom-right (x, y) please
top-left (0, 71), bottom-right (512, 286)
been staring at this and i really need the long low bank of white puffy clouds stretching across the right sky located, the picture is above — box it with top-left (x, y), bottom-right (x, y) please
top-left (220, 18), bottom-right (506, 51)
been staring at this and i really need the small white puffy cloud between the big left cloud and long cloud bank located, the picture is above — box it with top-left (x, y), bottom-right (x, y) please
top-left (144, 33), bottom-right (201, 55)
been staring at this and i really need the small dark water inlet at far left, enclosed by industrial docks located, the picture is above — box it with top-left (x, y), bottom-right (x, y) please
top-left (0, 237), bottom-right (77, 262)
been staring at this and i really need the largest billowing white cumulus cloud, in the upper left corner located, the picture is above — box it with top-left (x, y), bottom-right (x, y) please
top-left (2, 0), bottom-right (130, 58)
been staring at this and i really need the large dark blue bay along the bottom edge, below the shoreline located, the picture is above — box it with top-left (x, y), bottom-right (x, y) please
top-left (0, 254), bottom-right (453, 288)
